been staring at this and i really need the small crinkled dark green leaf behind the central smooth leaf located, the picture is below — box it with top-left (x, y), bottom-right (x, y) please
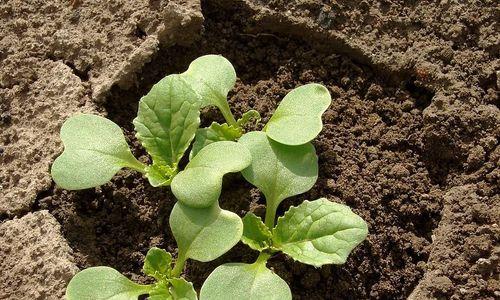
top-left (189, 122), bottom-right (243, 159)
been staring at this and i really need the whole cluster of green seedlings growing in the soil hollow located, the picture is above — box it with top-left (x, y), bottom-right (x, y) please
top-left (51, 55), bottom-right (368, 300)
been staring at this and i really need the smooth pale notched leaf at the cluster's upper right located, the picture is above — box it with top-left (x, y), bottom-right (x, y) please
top-left (264, 83), bottom-right (332, 145)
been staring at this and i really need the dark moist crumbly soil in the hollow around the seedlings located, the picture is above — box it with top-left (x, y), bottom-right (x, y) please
top-left (38, 2), bottom-right (454, 299)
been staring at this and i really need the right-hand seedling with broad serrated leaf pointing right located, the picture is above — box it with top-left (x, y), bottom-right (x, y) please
top-left (200, 84), bottom-right (368, 300)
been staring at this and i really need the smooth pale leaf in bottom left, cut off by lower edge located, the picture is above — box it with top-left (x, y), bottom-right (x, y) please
top-left (66, 267), bottom-right (152, 300)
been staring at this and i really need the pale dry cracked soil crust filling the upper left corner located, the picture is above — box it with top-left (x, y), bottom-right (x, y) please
top-left (0, 0), bottom-right (202, 215)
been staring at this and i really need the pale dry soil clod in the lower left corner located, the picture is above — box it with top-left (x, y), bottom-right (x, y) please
top-left (0, 210), bottom-right (78, 299)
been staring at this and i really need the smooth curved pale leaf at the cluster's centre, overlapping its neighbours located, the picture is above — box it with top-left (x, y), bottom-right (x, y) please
top-left (172, 141), bottom-right (251, 208)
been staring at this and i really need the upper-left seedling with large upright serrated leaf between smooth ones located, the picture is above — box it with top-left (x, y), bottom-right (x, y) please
top-left (51, 55), bottom-right (260, 190)
